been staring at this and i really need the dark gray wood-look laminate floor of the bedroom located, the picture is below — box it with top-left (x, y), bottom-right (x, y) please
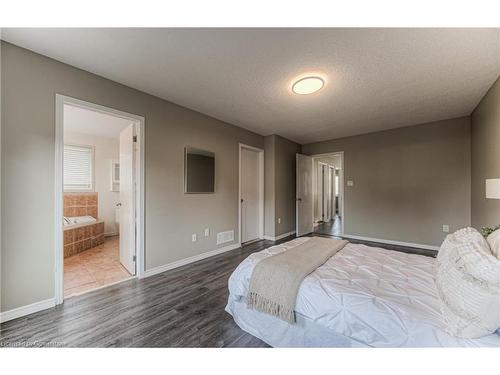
top-left (0, 238), bottom-right (436, 347)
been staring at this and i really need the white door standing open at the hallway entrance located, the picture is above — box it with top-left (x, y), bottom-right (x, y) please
top-left (296, 154), bottom-right (314, 236)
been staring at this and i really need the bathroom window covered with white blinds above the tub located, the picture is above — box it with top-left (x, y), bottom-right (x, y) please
top-left (64, 145), bottom-right (94, 191)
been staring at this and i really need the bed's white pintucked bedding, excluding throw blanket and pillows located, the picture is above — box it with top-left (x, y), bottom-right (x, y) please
top-left (226, 237), bottom-right (500, 347)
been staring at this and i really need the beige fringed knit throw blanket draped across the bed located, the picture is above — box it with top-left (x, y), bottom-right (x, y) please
top-left (246, 237), bottom-right (347, 323)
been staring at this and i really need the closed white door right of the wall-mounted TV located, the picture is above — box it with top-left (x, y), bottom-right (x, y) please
top-left (240, 148), bottom-right (261, 242)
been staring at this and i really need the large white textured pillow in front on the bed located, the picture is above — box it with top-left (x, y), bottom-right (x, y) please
top-left (436, 228), bottom-right (500, 338)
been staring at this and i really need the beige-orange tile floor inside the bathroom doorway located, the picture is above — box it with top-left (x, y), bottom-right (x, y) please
top-left (64, 236), bottom-right (131, 298)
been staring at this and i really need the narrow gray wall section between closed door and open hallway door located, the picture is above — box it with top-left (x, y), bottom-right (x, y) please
top-left (264, 135), bottom-right (301, 237)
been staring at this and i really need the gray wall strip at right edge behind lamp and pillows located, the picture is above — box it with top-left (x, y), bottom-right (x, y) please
top-left (471, 78), bottom-right (500, 228)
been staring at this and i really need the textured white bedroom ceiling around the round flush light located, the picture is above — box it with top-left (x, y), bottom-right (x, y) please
top-left (2, 28), bottom-right (500, 143)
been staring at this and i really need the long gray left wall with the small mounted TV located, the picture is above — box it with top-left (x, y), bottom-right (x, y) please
top-left (1, 42), bottom-right (264, 311)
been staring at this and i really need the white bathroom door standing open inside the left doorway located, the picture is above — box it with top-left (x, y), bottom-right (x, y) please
top-left (120, 124), bottom-right (136, 275)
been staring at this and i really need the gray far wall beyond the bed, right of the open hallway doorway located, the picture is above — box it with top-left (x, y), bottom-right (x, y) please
top-left (302, 117), bottom-right (470, 246)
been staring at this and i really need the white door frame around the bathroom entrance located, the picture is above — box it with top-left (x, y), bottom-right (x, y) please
top-left (54, 94), bottom-right (145, 305)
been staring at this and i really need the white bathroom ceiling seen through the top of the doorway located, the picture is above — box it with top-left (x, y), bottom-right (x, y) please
top-left (64, 105), bottom-right (130, 138)
